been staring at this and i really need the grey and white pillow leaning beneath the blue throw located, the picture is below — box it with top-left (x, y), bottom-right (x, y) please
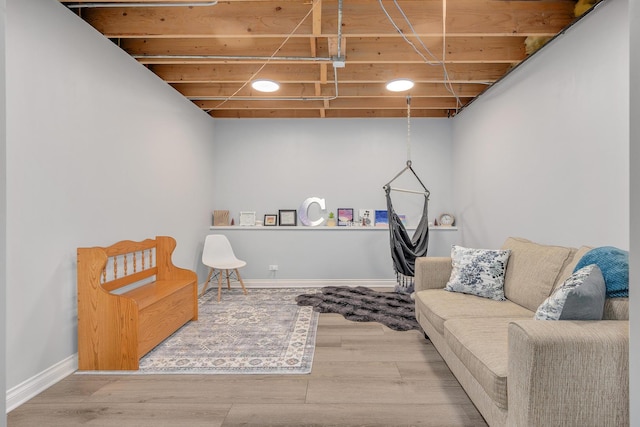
top-left (534, 264), bottom-right (606, 320)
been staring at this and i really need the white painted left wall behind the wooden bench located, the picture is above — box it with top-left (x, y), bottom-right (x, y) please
top-left (6, 0), bottom-right (214, 396)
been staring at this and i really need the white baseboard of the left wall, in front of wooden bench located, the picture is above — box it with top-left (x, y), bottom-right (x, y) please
top-left (7, 353), bottom-right (78, 413)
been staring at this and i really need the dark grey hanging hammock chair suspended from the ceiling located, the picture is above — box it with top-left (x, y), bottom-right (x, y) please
top-left (383, 161), bottom-right (430, 293)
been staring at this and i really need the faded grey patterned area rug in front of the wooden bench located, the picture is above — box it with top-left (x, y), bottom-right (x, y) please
top-left (77, 287), bottom-right (319, 375)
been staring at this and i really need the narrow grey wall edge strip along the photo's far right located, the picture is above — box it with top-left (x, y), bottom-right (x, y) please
top-left (629, 0), bottom-right (640, 426)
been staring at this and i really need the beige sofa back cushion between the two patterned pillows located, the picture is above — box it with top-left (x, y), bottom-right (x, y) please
top-left (502, 237), bottom-right (575, 311)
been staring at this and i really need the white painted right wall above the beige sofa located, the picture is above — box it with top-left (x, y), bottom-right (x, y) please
top-left (453, 0), bottom-right (629, 249)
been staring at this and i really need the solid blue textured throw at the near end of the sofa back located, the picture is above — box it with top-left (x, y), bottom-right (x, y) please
top-left (573, 246), bottom-right (629, 298)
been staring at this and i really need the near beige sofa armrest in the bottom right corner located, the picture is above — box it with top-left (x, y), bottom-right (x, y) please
top-left (507, 319), bottom-right (629, 426)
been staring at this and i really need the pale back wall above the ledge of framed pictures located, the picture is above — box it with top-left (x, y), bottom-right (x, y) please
top-left (211, 118), bottom-right (452, 224)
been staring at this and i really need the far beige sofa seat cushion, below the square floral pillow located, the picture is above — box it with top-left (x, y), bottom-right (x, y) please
top-left (415, 289), bottom-right (534, 335)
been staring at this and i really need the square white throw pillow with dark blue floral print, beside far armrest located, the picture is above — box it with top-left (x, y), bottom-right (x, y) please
top-left (444, 245), bottom-right (511, 301)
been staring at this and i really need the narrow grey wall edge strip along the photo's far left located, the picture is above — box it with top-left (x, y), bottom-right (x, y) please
top-left (0, 0), bottom-right (7, 427)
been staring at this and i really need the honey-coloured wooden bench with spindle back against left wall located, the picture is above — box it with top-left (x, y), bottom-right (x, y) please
top-left (78, 236), bottom-right (198, 370)
